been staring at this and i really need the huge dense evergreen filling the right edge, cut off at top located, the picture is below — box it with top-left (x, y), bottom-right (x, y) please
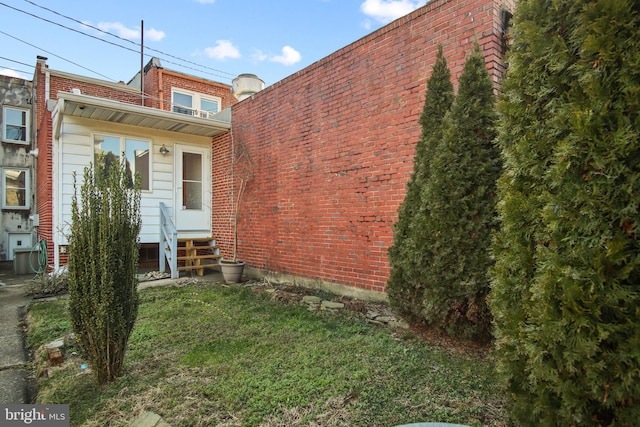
top-left (491, 0), bottom-right (640, 426)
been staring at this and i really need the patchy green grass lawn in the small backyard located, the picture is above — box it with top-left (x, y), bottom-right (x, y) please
top-left (28, 284), bottom-right (507, 426)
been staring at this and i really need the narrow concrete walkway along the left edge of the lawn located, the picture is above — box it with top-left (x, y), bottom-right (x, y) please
top-left (0, 268), bottom-right (33, 403)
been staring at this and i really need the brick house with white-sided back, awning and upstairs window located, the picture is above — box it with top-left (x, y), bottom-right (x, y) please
top-left (34, 58), bottom-right (235, 278)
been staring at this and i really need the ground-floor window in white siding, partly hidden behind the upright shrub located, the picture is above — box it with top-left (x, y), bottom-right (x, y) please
top-left (93, 135), bottom-right (151, 190)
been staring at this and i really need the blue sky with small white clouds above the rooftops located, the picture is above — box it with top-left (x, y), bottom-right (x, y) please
top-left (0, 0), bottom-right (427, 86)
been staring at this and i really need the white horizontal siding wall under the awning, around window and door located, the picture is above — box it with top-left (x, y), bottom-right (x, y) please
top-left (54, 117), bottom-right (211, 245)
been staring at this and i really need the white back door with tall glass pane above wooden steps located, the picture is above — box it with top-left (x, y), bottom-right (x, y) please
top-left (175, 144), bottom-right (211, 237)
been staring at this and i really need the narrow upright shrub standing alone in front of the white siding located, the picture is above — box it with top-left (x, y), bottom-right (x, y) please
top-left (68, 158), bottom-right (140, 384)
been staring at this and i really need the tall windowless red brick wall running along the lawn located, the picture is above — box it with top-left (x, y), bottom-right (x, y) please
top-left (212, 0), bottom-right (513, 291)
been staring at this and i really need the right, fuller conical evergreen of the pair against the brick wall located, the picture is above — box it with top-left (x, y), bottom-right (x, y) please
top-left (414, 44), bottom-right (501, 340)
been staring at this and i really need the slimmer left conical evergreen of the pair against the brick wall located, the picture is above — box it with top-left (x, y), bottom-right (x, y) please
top-left (387, 46), bottom-right (454, 320)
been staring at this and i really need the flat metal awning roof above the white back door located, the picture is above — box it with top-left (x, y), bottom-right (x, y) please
top-left (52, 92), bottom-right (231, 139)
